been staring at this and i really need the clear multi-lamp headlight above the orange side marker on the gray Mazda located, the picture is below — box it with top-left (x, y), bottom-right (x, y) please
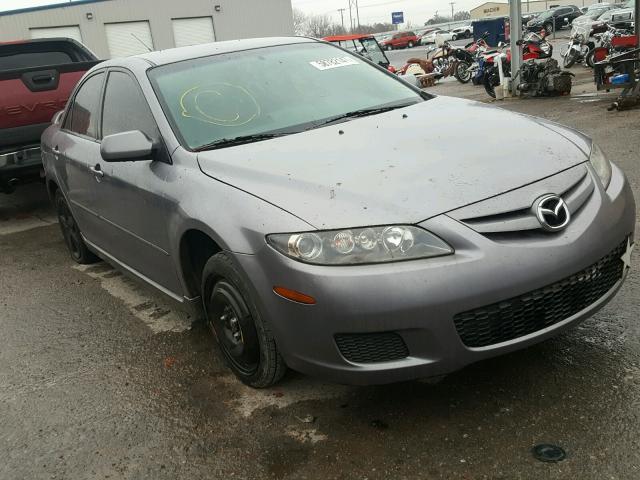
top-left (267, 225), bottom-right (453, 265)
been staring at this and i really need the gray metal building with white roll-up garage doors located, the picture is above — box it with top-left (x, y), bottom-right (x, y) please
top-left (0, 0), bottom-right (293, 59)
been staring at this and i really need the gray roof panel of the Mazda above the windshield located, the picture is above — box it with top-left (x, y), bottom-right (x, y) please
top-left (100, 37), bottom-right (318, 67)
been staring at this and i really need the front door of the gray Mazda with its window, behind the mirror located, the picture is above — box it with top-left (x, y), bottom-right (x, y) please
top-left (84, 69), bottom-right (182, 297)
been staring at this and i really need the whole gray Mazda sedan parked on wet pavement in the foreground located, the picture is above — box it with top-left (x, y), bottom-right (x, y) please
top-left (42, 38), bottom-right (636, 387)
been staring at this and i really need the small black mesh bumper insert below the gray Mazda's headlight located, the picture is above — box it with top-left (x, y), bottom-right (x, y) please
top-left (335, 332), bottom-right (409, 363)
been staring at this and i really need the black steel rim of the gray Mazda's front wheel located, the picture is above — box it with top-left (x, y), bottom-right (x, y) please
top-left (207, 280), bottom-right (260, 375)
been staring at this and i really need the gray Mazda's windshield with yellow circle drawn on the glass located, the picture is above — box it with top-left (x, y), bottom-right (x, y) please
top-left (149, 43), bottom-right (428, 150)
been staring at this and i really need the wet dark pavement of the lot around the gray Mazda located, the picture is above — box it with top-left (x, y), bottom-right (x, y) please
top-left (0, 66), bottom-right (640, 480)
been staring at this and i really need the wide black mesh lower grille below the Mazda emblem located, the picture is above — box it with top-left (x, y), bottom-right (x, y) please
top-left (453, 240), bottom-right (627, 347)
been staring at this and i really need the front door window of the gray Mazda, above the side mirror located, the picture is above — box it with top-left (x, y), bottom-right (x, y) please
top-left (102, 72), bottom-right (158, 139)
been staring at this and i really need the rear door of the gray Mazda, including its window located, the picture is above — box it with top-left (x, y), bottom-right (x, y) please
top-left (51, 72), bottom-right (106, 241)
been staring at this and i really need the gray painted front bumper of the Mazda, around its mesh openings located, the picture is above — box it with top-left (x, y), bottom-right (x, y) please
top-left (236, 166), bottom-right (635, 384)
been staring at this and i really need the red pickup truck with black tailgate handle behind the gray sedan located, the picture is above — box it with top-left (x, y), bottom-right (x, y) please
top-left (0, 38), bottom-right (98, 193)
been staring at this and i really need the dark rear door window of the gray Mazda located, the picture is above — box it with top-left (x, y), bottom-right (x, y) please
top-left (64, 73), bottom-right (104, 138)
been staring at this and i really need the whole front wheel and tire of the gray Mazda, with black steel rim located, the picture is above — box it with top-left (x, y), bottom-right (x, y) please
top-left (201, 252), bottom-right (287, 388)
